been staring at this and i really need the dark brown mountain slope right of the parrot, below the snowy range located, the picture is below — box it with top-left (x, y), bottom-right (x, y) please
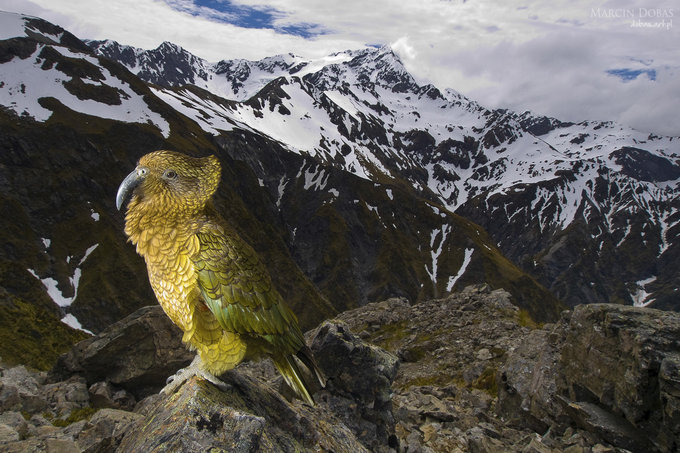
top-left (218, 132), bottom-right (564, 321)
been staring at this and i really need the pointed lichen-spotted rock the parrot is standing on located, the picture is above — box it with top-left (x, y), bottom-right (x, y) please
top-left (118, 371), bottom-right (368, 453)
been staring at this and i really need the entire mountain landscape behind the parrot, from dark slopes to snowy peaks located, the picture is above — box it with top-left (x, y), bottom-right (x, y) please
top-left (0, 13), bottom-right (680, 369)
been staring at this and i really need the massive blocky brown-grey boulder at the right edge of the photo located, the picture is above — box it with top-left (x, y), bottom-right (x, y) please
top-left (557, 304), bottom-right (680, 452)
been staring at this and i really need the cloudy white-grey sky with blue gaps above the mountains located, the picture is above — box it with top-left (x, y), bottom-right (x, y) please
top-left (0, 0), bottom-right (680, 135)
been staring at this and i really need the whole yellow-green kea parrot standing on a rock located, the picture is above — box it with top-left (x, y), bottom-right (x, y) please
top-left (116, 150), bottom-right (325, 405)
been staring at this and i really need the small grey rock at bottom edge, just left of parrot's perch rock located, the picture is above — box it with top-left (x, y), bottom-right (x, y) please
top-left (76, 409), bottom-right (143, 453)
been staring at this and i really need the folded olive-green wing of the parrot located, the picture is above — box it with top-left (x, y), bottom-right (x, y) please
top-left (194, 227), bottom-right (305, 354)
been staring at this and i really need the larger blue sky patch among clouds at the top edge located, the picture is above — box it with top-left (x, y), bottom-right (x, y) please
top-left (165, 0), bottom-right (325, 38)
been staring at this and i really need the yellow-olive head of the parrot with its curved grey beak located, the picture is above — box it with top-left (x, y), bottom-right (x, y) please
top-left (116, 150), bottom-right (222, 212)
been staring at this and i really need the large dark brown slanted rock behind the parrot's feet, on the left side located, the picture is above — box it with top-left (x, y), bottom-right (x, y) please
top-left (49, 305), bottom-right (194, 399)
